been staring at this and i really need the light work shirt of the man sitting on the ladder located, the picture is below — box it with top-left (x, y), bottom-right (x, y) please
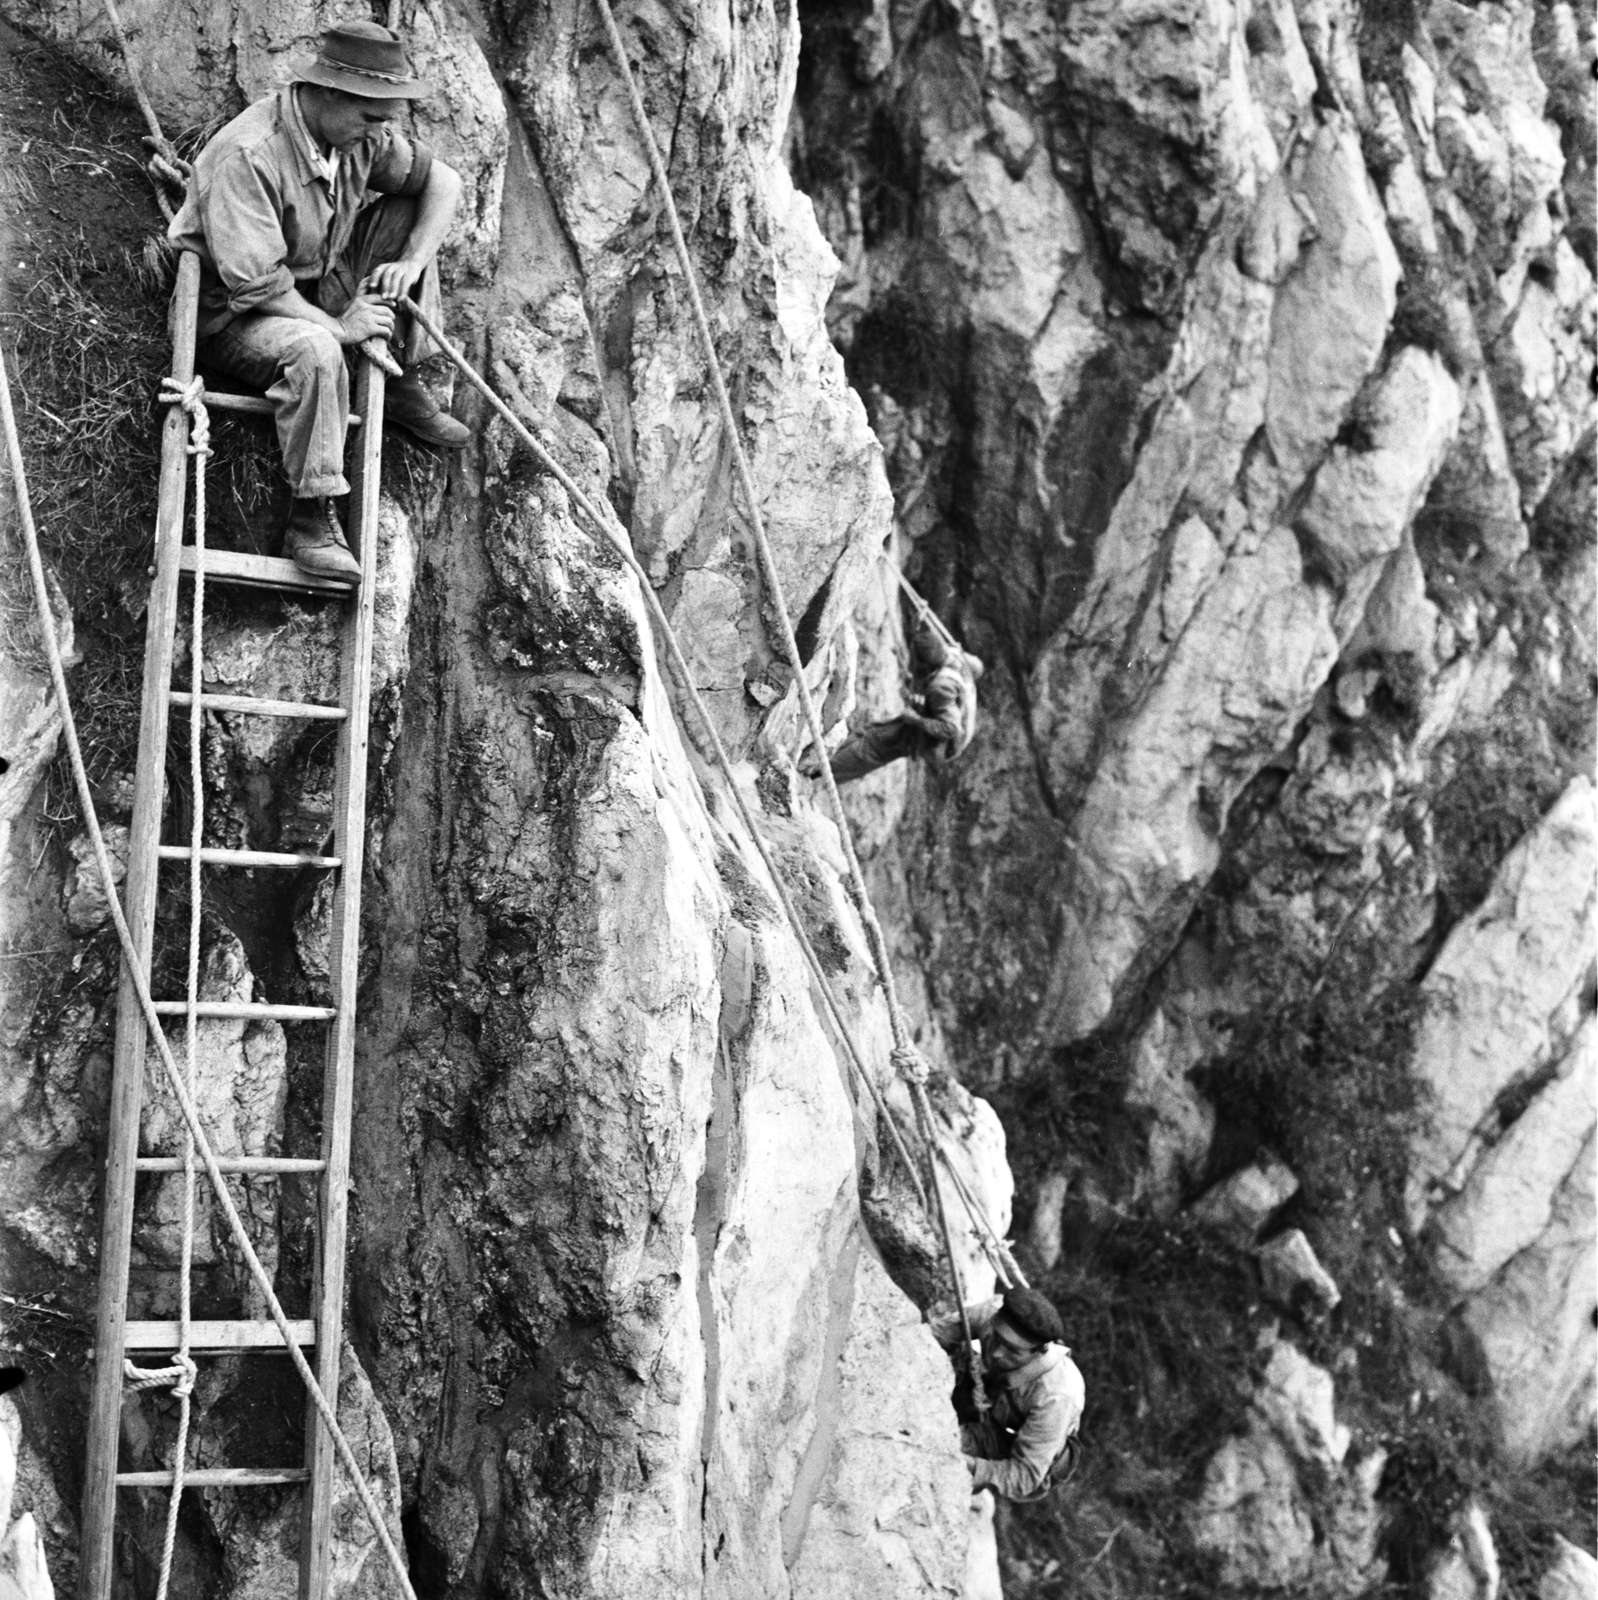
top-left (166, 83), bottom-right (433, 338)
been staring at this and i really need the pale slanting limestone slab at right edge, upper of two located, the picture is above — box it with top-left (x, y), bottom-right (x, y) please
top-left (1409, 776), bottom-right (1598, 1226)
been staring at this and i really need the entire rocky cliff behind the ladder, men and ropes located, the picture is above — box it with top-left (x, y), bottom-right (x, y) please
top-left (0, 0), bottom-right (1595, 1597)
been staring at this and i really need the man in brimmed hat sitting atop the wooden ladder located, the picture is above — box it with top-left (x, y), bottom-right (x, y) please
top-left (168, 22), bottom-right (472, 581)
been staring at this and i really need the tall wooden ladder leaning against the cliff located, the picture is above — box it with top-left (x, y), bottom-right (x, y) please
top-left (80, 254), bottom-right (384, 1600)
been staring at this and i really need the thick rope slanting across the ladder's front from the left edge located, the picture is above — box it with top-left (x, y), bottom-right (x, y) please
top-left (0, 340), bottom-right (416, 1600)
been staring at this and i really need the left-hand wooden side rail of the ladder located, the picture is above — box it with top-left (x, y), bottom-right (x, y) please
top-left (78, 251), bottom-right (200, 1600)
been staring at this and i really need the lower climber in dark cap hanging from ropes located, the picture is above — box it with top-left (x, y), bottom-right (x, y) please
top-left (931, 1288), bottom-right (1086, 1499)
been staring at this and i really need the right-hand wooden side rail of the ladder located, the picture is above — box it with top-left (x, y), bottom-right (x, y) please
top-left (299, 360), bottom-right (384, 1600)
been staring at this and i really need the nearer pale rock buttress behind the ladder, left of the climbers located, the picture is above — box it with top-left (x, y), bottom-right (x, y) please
top-left (6, 5), bottom-right (1008, 1595)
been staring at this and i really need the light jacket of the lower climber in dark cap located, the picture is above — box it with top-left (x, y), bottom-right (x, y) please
top-left (931, 1296), bottom-right (1086, 1499)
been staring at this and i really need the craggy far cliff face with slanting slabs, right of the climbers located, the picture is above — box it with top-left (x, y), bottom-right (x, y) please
top-left (790, 0), bottom-right (1595, 1594)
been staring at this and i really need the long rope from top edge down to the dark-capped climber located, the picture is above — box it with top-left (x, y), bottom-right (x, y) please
top-left (595, 0), bottom-right (985, 1405)
